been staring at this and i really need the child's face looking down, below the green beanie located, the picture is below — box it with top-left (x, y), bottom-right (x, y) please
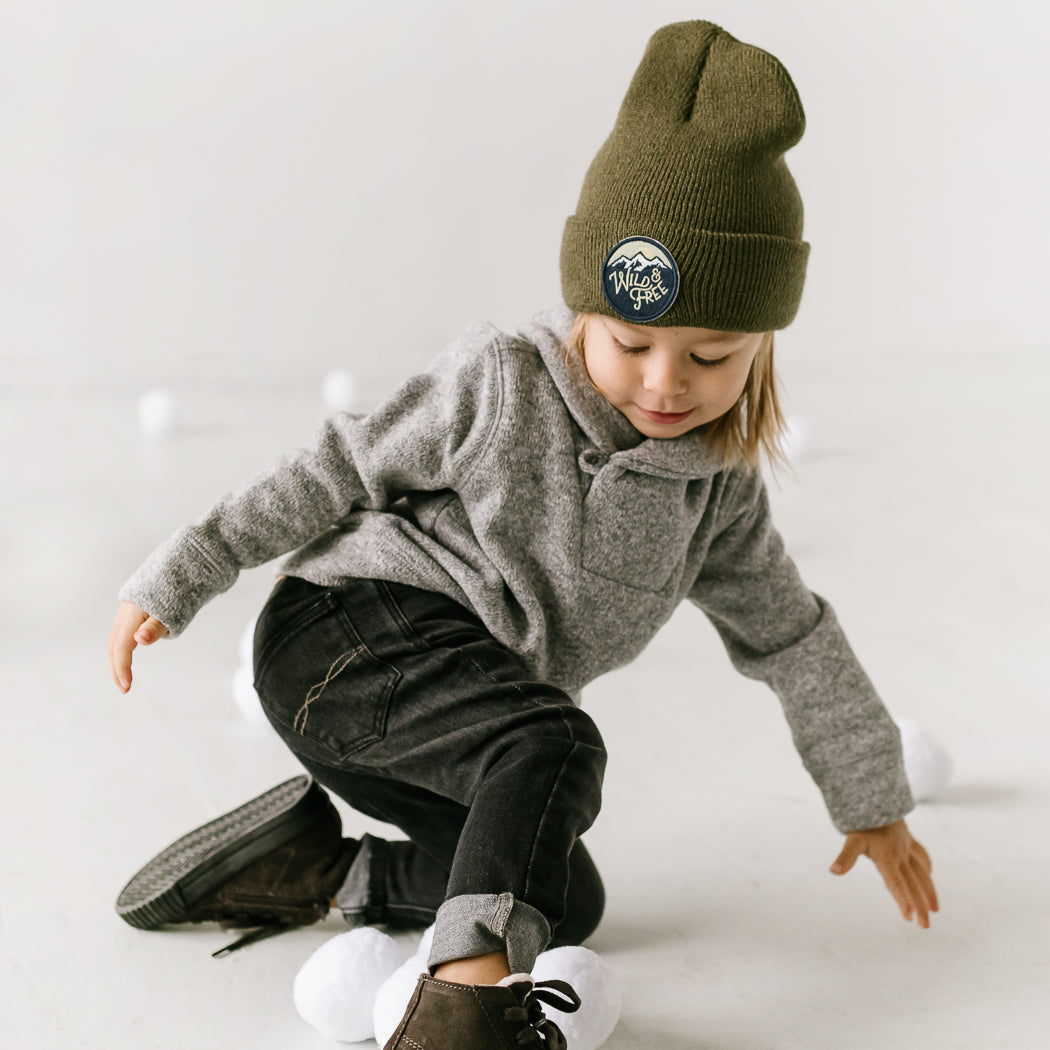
top-left (584, 314), bottom-right (763, 438)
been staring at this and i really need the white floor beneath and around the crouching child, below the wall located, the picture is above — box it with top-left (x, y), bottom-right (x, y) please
top-left (0, 338), bottom-right (1050, 1050)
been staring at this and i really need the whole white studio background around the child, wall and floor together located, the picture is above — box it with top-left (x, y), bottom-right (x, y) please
top-left (0, 8), bottom-right (1050, 1050)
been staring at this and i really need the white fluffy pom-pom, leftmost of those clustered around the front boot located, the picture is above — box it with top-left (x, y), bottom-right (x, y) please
top-left (300, 926), bottom-right (404, 1046)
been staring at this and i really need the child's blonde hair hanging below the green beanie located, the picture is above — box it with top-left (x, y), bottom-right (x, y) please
top-left (566, 314), bottom-right (791, 474)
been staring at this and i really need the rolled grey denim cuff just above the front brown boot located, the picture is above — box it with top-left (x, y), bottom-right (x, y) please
top-left (427, 894), bottom-right (551, 973)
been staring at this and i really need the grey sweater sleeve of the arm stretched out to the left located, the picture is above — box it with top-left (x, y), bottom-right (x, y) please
top-left (119, 330), bottom-right (500, 637)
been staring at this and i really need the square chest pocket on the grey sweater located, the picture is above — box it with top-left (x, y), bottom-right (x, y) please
top-left (581, 464), bottom-right (696, 592)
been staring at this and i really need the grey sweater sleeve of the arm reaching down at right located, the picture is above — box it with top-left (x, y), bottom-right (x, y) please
top-left (689, 471), bottom-right (914, 833)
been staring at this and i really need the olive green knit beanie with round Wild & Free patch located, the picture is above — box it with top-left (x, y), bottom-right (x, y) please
top-left (562, 22), bottom-right (810, 332)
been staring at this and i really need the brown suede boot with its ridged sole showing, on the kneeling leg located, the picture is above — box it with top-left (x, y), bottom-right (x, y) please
top-left (117, 776), bottom-right (357, 954)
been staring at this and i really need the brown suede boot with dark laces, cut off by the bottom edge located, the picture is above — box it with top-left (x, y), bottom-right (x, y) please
top-left (384, 973), bottom-right (580, 1050)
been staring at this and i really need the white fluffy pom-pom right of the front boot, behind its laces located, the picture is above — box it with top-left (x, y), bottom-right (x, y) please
top-left (532, 947), bottom-right (623, 1050)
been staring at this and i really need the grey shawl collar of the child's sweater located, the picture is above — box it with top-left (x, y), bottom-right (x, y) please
top-left (521, 307), bottom-right (723, 479)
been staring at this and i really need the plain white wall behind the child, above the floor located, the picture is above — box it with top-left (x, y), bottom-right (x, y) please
top-left (8, 0), bottom-right (1050, 396)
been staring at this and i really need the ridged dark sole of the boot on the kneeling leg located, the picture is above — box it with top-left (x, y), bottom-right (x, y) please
top-left (117, 776), bottom-right (329, 929)
